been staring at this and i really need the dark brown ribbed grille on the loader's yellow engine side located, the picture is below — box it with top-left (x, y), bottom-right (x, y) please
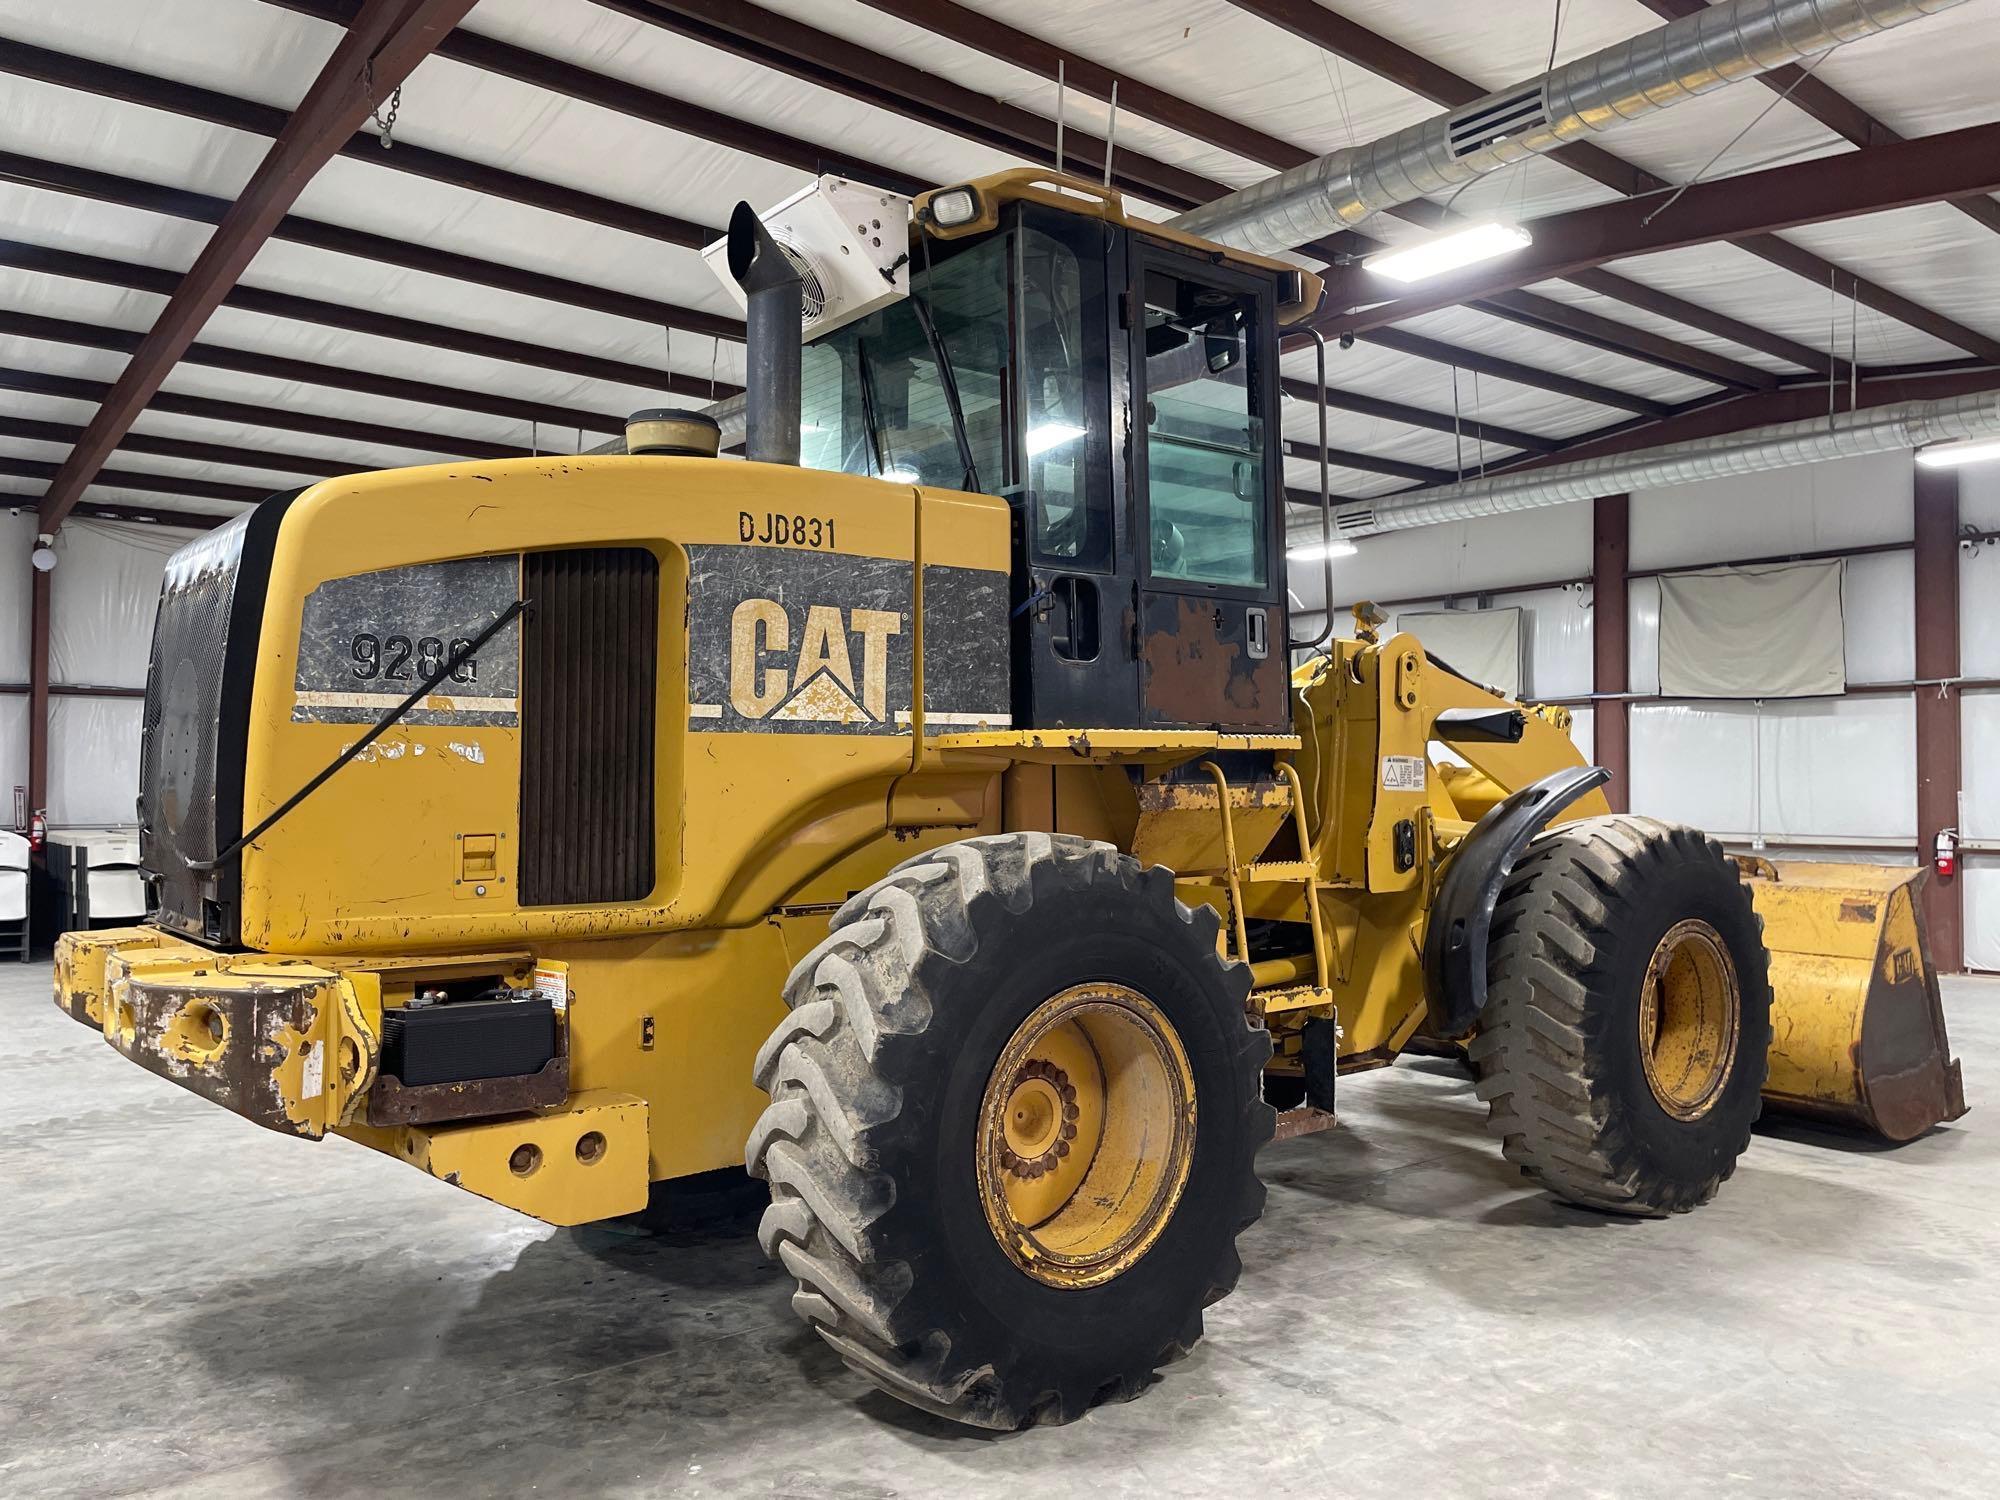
top-left (520, 548), bottom-right (660, 906)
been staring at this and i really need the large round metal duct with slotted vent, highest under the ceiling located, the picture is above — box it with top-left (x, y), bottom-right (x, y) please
top-left (1170, 0), bottom-right (1964, 254)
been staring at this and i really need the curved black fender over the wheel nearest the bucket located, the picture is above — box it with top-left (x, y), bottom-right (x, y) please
top-left (1424, 766), bottom-right (1612, 1036)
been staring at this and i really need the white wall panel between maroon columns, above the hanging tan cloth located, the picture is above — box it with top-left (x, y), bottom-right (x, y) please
top-left (1632, 452), bottom-right (1914, 568)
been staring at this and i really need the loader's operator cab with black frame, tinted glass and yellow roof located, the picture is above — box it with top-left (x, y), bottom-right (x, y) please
top-left (744, 172), bottom-right (1320, 732)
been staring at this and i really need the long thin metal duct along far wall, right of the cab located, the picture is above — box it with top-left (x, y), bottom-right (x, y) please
top-left (1292, 390), bottom-right (2000, 546)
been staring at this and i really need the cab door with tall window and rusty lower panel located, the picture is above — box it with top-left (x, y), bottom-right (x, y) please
top-left (1124, 236), bottom-right (1290, 732)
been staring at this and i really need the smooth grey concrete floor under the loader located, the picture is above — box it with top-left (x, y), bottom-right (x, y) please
top-left (0, 966), bottom-right (2000, 1500)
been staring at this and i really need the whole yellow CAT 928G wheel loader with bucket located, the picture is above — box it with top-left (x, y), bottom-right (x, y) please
top-left (56, 172), bottom-right (1962, 1428)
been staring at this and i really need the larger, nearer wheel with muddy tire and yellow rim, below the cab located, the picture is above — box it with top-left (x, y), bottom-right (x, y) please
top-left (746, 834), bottom-right (1274, 1428)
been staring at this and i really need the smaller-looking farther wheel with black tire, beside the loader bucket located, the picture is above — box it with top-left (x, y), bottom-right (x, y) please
top-left (1468, 814), bottom-right (1770, 1216)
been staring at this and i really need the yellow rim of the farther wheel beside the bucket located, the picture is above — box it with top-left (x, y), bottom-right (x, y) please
top-left (1638, 918), bottom-right (1744, 1120)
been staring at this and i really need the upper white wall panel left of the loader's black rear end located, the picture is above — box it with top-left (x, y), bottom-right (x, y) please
top-left (48, 520), bottom-right (190, 688)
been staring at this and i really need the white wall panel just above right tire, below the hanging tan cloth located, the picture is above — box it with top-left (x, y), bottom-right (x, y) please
top-left (1630, 704), bottom-right (1758, 834)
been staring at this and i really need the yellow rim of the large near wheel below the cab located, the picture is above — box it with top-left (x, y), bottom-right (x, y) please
top-left (976, 984), bottom-right (1194, 1288)
